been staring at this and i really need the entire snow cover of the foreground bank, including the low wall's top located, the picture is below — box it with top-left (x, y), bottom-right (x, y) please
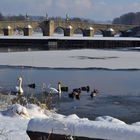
top-left (0, 104), bottom-right (140, 140)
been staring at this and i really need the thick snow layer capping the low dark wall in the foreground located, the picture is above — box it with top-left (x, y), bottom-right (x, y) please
top-left (27, 115), bottom-right (140, 140)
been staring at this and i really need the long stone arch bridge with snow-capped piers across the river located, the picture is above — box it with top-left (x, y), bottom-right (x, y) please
top-left (0, 20), bottom-right (137, 36)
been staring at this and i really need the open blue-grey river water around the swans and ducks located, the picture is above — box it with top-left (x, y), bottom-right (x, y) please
top-left (0, 67), bottom-right (140, 123)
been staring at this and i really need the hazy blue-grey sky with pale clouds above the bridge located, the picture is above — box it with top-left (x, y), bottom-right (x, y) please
top-left (0, 0), bottom-right (140, 21)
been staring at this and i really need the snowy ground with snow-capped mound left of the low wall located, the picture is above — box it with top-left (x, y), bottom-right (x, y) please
top-left (0, 104), bottom-right (49, 140)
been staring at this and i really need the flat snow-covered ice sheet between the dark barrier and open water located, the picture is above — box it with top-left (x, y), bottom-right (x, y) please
top-left (0, 49), bottom-right (140, 69)
